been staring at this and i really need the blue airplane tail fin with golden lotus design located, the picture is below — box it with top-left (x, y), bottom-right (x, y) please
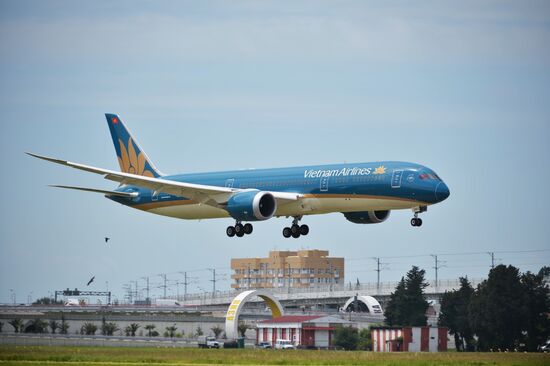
top-left (105, 113), bottom-right (162, 178)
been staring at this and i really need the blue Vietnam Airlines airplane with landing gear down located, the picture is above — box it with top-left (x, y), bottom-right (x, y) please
top-left (27, 114), bottom-right (450, 238)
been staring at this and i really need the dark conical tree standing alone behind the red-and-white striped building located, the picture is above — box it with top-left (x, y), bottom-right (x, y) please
top-left (384, 266), bottom-right (428, 326)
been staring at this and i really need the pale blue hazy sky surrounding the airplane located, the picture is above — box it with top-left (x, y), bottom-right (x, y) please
top-left (0, 0), bottom-right (550, 303)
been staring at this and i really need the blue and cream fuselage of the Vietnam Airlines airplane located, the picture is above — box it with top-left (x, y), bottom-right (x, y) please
top-left (109, 161), bottom-right (449, 219)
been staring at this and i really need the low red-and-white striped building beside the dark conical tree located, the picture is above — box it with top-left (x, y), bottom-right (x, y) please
top-left (371, 327), bottom-right (447, 352)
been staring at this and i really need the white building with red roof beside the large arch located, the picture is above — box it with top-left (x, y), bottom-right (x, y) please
top-left (256, 315), bottom-right (355, 348)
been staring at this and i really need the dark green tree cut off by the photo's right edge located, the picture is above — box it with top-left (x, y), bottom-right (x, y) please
top-left (521, 267), bottom-right (550, 352)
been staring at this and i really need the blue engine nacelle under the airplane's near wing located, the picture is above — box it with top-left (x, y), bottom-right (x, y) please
top-left (225, 191), bottom-right (277, 221)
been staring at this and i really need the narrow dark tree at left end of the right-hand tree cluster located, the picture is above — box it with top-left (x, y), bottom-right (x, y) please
top-left (439, 277), bottom-right (474, 351)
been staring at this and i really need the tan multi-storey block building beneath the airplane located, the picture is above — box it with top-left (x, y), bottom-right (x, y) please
top-left (231, 249), bottom-right (344, 290)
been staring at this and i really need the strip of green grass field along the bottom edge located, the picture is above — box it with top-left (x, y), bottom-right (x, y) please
top-left (0, 346), bottom-right (550, 366)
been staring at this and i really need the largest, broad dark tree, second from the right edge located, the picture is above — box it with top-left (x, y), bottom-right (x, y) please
top-left (468, 265), bottom-right (524, 351)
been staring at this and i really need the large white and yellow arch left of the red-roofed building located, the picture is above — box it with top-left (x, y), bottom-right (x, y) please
top-left (225, 290), bottom-right (284, 339)
